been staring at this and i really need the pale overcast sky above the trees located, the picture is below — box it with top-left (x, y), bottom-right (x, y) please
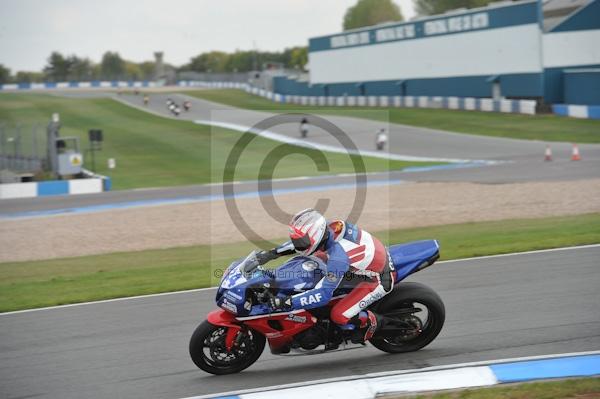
top-left (0, 0), bottom-right (414, 73)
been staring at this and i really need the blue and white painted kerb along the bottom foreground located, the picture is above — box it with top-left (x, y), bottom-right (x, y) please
top-left (188, 351), bottom-right (600, 399)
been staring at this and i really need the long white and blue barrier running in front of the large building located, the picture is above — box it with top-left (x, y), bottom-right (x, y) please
top-left (178, 81), bottom-right (536, 115)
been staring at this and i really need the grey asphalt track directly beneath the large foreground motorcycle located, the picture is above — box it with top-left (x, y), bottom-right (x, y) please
top-left (0, 246), bottom-right (600, 399)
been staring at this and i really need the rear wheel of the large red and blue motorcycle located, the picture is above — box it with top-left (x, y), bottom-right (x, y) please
top-left (369, 283), bottom-right (446, 353)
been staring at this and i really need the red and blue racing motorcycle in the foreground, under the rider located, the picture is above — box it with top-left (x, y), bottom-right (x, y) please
top-left (189, 240), bottom-right (445, 375)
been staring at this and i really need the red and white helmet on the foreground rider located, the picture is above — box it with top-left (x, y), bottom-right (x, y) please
top-left (289, 208), bottom-right (327, 255)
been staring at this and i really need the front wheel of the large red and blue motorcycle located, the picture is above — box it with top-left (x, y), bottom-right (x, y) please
top-left (190, 320), bottom-right (265, 375)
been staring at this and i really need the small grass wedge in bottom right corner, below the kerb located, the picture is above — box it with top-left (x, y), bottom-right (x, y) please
top-left (412, 377), bottom-right (600, 399)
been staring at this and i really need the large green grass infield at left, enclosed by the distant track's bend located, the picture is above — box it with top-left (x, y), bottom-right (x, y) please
top-left (0, 93), bottom-right (440, 189)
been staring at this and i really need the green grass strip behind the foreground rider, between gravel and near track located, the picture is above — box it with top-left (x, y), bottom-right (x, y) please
top-left (0, 213), bottom-right (600, 312)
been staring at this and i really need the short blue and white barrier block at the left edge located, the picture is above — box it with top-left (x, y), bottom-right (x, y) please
top-left (0, 176), bottom-right (111, 200)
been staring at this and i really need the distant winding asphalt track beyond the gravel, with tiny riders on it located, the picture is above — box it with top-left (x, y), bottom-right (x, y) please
top-left (0, 91), bottom-right (600, 217)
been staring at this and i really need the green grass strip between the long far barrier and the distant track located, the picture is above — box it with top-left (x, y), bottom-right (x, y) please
top-left (185, 90), bottom-right (600, 143)
